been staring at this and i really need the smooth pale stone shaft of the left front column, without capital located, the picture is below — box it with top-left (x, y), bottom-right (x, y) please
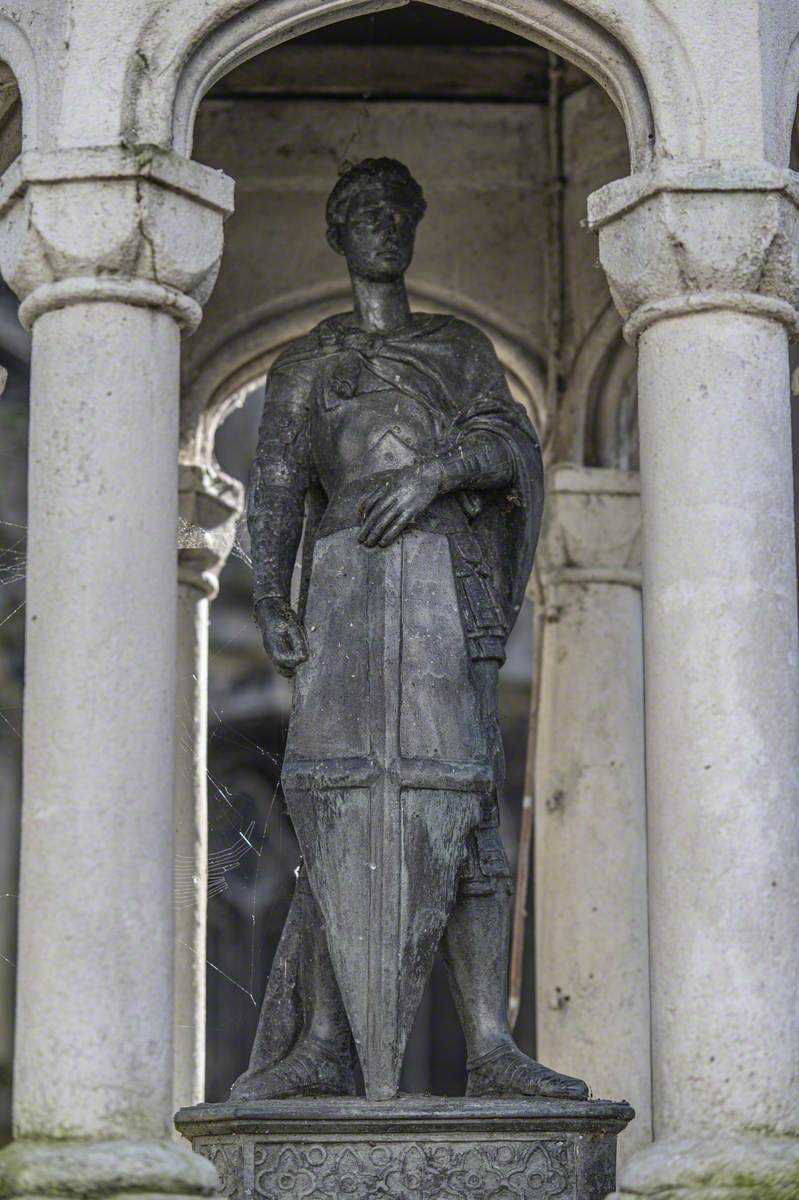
top-left (14, 302), bottom-right (179, 1138)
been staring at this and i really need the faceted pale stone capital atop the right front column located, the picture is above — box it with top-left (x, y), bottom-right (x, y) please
top-left (588, 160), bottom-right (799, 342)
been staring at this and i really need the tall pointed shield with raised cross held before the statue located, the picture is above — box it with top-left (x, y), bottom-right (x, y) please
top-left (283, 529), bottom-right (492, 1099)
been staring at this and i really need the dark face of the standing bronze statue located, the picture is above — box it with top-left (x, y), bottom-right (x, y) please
top-left (340, 187), bottom-right (416, 280)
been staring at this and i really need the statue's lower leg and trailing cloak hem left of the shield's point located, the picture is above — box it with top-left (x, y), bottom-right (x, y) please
top-left (232, 871), bottom-right (355, 1100)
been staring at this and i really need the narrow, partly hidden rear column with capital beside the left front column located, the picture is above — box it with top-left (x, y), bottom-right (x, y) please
top-left (173, 463), bottom-right (244, 1111)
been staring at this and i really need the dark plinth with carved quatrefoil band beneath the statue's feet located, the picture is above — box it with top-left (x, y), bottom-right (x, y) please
top-left (175, 1097), bottom-right (633, 1200)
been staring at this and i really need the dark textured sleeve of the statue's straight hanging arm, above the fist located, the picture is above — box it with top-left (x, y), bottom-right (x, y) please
top-left (247, 358), bottom-right (313, 605)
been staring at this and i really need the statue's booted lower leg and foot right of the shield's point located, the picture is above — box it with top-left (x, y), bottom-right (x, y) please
top-left (441, 881), bottom-right (588, 1100)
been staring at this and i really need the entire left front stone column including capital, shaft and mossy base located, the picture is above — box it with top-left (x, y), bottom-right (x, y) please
top-left (0, 146), bottom-right (232, 1196)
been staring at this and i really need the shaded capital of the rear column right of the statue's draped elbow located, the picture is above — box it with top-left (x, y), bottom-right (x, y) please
top-left (536, 463), bottom-right (641, 594)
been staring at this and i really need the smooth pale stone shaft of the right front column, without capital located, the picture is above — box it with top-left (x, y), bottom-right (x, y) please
top-left (639, 312), bottom-right (799, 1138)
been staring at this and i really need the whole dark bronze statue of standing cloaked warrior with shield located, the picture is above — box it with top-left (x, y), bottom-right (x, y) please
top-left (233, 158), bottom-right (588, 1099)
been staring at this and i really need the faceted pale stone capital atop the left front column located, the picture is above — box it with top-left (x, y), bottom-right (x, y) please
top-left (0, 146), bottom-right (233, 332)
